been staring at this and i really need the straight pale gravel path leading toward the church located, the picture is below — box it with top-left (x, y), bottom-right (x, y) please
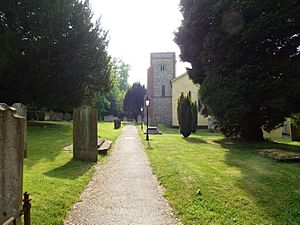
top-left (65, 125), bottom-right (180, 225)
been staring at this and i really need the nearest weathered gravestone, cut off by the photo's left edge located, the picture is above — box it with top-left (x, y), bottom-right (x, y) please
top-left (0, 103), bottom-right (25, 225)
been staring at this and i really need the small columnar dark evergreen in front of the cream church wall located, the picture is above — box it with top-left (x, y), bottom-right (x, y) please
top-left (177, 93), bottom-right (193, 138)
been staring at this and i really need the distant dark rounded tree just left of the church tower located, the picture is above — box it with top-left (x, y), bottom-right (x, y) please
top-left (123, 83), bottom-right (146, 121)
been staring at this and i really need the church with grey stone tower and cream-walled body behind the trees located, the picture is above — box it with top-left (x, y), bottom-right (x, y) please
top-left (147, 52), bottom-right (288, 138)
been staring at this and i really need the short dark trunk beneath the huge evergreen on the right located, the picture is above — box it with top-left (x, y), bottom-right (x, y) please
top-left (241, 119), bottom-right (264, 141)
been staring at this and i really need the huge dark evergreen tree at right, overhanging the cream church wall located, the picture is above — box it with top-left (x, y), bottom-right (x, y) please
top-left (175, 0), bottom-right (300, 140)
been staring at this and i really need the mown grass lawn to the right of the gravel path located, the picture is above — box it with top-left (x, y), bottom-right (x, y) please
top-left (140, 127), bottom-right (300, 225)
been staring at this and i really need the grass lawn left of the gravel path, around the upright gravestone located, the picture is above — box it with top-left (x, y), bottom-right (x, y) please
top-left (23, 122), bottom-right (121, 225)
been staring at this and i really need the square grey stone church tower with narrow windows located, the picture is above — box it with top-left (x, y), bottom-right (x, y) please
top-left (147, 52), bottom-right (176, 126)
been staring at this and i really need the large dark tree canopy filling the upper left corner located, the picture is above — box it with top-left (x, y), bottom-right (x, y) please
top-left (0, 0), bottom-right (110, 109)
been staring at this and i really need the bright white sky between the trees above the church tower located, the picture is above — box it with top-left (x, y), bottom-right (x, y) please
top-left (90, 0), bottom-right (188, 84)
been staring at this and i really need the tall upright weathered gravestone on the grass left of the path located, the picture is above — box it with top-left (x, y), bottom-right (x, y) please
top-left (73, 106), bottom-right (98, 162)
